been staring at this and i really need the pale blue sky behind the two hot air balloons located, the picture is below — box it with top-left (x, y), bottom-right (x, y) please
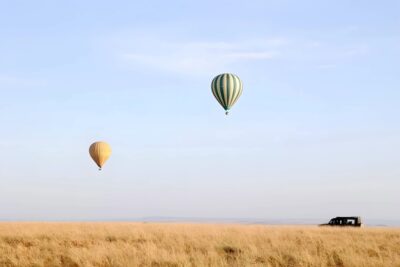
top-left (0, 0), bottom-right (400, 223)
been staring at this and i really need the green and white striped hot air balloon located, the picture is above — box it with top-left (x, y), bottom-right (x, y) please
top-left (211, 73), bottom-right (243, 115)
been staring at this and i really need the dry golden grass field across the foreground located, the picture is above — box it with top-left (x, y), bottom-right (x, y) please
top-left (0, 223), bottom-right (400, 267)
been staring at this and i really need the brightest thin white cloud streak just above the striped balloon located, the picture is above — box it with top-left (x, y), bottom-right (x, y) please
top-left (120, 39), bottom-right (287, 74)
